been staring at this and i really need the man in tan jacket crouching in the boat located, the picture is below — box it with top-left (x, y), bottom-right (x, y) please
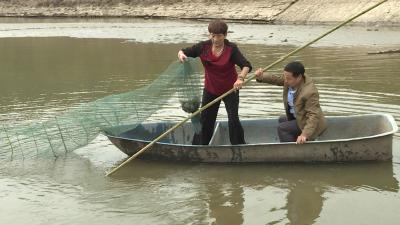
top-left (256, 61), bottom-right (327, 144)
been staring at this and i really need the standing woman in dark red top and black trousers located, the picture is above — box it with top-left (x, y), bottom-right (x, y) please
top-left (178, 20), bottom-right (252, 145)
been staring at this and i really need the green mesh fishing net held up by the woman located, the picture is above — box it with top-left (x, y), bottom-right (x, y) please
top-left (0, 58), bottom-right (203, 160)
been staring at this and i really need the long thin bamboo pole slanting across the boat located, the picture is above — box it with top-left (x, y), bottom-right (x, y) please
top-left (106, 0), bottom-right (387, 176)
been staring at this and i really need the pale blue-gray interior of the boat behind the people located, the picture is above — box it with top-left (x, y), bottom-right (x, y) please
top-left (104, 114), bottom-right (397, 146)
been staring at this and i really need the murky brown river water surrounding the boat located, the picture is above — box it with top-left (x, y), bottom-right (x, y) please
top-left (0, 19), bottom-right (400, 225)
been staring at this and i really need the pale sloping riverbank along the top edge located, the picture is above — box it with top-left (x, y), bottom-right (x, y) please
top-left (0, 0), bottom-right (400, 26)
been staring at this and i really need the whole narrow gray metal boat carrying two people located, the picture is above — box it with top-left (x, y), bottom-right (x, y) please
top-left (104, 114), bottom-right (398, 163)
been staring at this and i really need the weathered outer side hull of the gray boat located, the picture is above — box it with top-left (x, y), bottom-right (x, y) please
top-left (109, 135), bottom-right (393, 163)
